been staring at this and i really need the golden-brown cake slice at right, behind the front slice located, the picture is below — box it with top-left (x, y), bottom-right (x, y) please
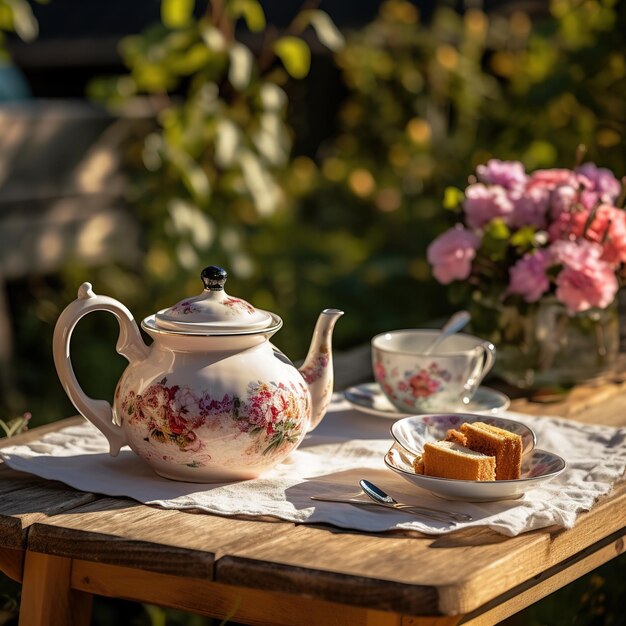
top-left (461, 422), bottom-right (522, 480)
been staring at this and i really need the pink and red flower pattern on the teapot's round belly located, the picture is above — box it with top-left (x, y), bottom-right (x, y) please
top-left (118, 378), bottom-right (310, 467)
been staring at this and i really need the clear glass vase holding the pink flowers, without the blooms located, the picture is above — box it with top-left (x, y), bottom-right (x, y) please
top-left (472, 297), bottom-right (619, 389)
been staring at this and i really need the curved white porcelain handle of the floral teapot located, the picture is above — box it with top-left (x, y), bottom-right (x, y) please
top-left (52, 283), bottom-right (150, 456)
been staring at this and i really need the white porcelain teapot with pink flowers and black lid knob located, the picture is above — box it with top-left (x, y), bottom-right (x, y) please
top-left (53, 266), bottom-right (343, 482)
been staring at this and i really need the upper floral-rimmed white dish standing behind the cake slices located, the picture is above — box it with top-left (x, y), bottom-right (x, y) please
top-left (391, 413), bottom-right (537, 455)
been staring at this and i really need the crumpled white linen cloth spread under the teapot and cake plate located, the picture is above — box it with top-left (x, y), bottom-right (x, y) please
top-left (0, 394), bottom-right (626, 536)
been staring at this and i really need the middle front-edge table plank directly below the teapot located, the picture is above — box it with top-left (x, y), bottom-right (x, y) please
top-left (29, 498), bottom-right (292, 579)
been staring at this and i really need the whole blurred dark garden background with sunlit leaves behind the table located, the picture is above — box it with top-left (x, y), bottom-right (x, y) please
top-left (0, 0), bottom-right (626, 625)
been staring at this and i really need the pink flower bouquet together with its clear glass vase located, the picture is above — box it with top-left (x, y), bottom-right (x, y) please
top-left (427, 159), bottom-right (626, 387)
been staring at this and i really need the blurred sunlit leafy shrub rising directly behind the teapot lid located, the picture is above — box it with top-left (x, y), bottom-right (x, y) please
top-left (83, 0), bottom-right (342, 356)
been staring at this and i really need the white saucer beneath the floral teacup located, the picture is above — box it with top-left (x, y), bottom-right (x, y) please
top-left (343, 383), bottom-right (511, 420)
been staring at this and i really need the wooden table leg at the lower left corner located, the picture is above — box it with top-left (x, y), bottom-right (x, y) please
top-left (19, 551), bottom-right (92, 626)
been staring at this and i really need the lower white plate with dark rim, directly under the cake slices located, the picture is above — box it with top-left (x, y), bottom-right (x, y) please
top-left (385, 442), bottom-right (567, 502)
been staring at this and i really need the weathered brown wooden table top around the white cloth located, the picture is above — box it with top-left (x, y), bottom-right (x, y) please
top-left (0, 382), bottom-right (626, 623)
